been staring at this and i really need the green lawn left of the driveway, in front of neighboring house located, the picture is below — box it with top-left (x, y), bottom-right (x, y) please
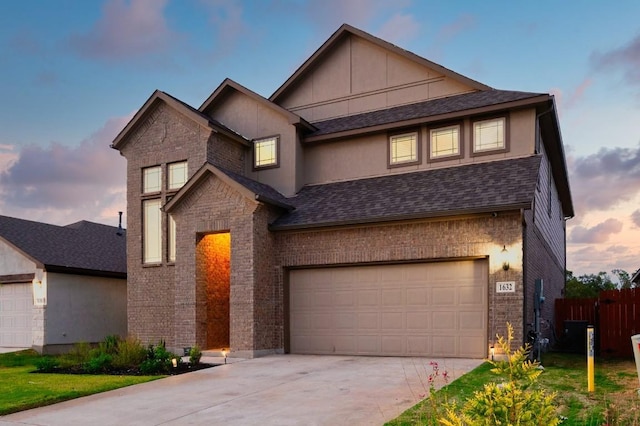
top-left (0, 350), bottom-right (164, 415)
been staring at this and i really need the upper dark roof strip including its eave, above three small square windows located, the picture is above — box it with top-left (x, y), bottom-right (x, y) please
top-left (305, 89), bottom-right (549, 142)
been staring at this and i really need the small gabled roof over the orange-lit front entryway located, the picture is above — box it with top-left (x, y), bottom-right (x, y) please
top-left (163, 162), bottom-right (293, 212)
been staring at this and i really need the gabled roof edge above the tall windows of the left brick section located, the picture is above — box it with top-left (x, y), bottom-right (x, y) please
top-left (111, 90), bottom-right (249, 150)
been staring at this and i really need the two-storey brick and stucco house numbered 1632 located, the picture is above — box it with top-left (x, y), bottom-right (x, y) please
top-left (112, 25), bottom-right (574, 358)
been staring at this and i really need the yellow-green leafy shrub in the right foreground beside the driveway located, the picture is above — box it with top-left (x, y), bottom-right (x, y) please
top-left (439, 323), bottom-right (561, 426)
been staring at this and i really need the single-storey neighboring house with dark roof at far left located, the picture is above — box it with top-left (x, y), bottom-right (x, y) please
top-left (0, 216), bottom-right (127, 353)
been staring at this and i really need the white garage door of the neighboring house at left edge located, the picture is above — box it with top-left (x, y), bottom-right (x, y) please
top-left (0, 284), bottom-right (33, 348)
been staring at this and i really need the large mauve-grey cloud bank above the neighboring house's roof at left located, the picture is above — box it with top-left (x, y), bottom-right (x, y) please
top-left (0, 117), bottom-right (130, 224)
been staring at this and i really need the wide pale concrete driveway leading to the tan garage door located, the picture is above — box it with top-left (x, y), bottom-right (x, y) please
top-left (0, 355), bottom-right (482, 426)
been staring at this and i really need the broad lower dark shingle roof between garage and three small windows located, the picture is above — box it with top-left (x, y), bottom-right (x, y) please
top-left (272, 156), bottom-right (540, 230)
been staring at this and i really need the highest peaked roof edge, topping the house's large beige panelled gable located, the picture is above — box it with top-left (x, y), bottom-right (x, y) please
top-left (269, 24), bottom-right (491, 103)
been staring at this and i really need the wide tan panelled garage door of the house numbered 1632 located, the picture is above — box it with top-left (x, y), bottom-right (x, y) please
top-left (289, 260), bottom-right (488, 358)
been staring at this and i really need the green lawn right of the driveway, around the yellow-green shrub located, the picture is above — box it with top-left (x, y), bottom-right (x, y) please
top-left (387, 353), bottom-right (640, 426)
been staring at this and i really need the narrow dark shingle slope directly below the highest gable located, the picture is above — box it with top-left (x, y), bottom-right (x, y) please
top-left (307, 89), bottom-right (545, 137)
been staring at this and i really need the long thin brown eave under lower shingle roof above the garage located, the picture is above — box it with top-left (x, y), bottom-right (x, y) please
top-left (269, 201), bottom-right (531, 231)
